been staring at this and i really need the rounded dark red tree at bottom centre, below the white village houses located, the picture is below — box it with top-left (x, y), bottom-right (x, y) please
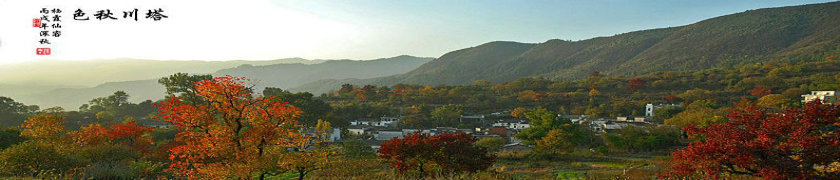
top-left (379, 132), bottom-right (495, 176)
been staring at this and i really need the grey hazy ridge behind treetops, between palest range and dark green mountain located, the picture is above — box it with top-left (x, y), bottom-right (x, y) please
top-left (11, 56), bottom-right (432, 109)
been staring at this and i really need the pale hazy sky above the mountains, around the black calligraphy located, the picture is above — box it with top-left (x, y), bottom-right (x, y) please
top-left (0, 0), bottom-right (827, 63)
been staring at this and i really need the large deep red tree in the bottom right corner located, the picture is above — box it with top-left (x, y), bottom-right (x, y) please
top-left (666, 103), bottom-right (840, 179)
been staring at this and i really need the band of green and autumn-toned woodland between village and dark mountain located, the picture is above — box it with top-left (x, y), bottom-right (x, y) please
top-left (320, 56), bottom-right (840, 127)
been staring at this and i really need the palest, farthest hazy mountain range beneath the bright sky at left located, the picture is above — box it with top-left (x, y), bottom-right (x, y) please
top-left (0, 58), bottom-right (325, 87)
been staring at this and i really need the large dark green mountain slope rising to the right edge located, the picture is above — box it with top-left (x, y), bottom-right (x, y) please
top-left (296, 2), bottom-right (840, 92)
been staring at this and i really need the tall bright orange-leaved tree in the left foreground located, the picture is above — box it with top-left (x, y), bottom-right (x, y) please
top-left (155, 76), bottom-right (305, 179)
